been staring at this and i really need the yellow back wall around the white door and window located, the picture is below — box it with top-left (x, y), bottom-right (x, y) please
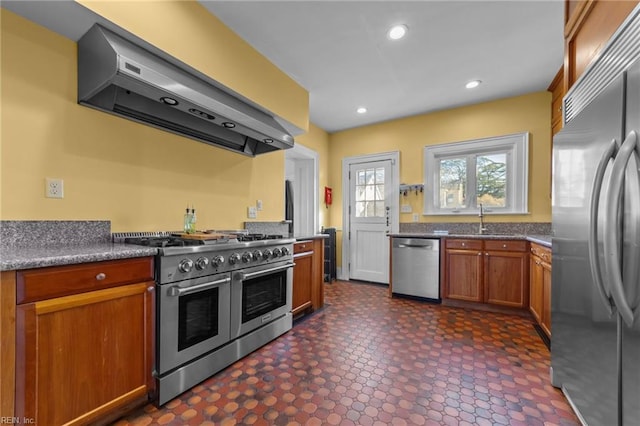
top-left (329, 91), bottom-right (551, 228)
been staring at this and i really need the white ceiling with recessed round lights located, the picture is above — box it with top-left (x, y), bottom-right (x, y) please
top-left (2, 0), bottom-right (564, 132)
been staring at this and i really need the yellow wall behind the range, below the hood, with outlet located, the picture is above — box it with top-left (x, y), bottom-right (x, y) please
top-left (0, 9), bottom-right (326, 232)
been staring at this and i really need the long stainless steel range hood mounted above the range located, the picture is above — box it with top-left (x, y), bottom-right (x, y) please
top-left (78, 24), bottom-right (293, 156)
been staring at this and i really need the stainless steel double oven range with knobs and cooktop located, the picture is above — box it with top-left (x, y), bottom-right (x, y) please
top-left (114, 233), bottom-right (294, 405)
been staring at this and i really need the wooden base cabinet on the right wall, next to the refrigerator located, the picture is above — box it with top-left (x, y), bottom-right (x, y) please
top-left (529, 243), bottom-right (551, 337)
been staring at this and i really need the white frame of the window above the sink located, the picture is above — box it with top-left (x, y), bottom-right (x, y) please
top-left (423, 132), bottom-right (529, 216)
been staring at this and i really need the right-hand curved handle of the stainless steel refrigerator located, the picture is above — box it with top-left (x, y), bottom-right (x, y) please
top-left (604, 131), bottom-right (640, 327)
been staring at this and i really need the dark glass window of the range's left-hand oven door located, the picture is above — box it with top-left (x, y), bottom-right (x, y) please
top-left (178, 288), bottom-right (220, 351)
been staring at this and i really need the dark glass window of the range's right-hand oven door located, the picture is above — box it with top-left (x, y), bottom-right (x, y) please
top-left (242, 271), bottom-right (287, 323)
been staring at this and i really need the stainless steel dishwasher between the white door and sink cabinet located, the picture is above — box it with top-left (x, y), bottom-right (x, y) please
top-left (391, 238), bottom-right (440, 301)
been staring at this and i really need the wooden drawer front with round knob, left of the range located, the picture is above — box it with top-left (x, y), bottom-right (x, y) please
top-left (16, 257), bottom-right (153, 303)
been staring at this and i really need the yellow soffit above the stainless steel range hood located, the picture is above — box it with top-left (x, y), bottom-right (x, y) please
top-left (76, 0), bottom-right (309, 131)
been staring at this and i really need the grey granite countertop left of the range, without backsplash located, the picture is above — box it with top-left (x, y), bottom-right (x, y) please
top-left (0, 243), bottom-right (158, 271)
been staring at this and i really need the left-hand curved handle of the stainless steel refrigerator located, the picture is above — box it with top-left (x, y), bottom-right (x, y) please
top-left (588, 139), bottom-right (618, 316)
